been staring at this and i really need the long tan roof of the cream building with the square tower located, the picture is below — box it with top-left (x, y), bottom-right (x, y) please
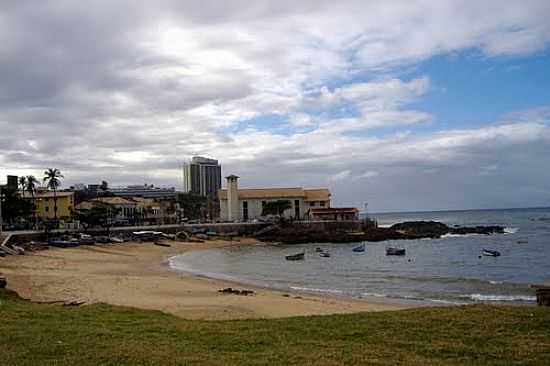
top-left (218, 187), bottom-right (330, 201)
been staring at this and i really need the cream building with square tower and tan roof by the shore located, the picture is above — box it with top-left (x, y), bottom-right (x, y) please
top-left (218, 175), bottom-right (330, 221)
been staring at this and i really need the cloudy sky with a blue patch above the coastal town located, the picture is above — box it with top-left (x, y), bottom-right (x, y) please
top-left (0, 0), bottom-right (550, 212)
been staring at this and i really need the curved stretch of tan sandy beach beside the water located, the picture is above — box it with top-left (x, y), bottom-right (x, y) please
top-left (0, 239), bottom-right (404, 320)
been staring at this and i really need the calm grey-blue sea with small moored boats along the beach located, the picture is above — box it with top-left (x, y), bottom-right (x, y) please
top-left (170, 208), bottom-right (550, 304)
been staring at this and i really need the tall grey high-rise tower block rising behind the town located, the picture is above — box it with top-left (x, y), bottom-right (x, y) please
top-left (183, 156), bottom-right (222, 198)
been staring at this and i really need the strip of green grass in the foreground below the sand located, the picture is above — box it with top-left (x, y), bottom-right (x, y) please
top-left (0, 290), bottom-right (550, 366)
